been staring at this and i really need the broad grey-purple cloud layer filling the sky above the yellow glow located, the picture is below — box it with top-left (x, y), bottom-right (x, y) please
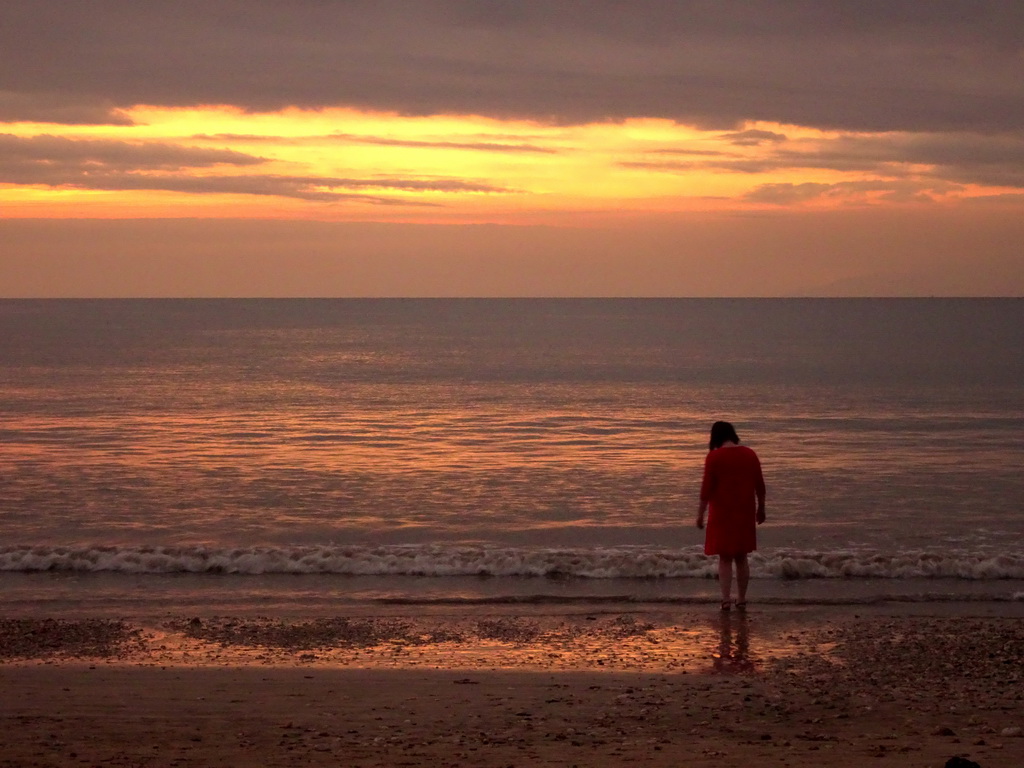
top-left (0, 0), bottom-right (1024, 132)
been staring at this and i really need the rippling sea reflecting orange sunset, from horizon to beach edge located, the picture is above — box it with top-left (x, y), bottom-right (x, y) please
top-left (0, 299), bottom-right (1024, 604)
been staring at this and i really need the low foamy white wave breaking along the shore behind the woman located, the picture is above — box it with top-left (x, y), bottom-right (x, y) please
top-left (0, 545), bottom-right (1024, 581)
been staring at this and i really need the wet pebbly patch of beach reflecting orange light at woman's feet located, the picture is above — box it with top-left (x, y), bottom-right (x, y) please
top-left (70, 611), bottom-right (820, 675)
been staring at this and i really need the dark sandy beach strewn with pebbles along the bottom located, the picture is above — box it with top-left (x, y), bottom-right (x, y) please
top-left (0, 604), bottom-right (1024, 768)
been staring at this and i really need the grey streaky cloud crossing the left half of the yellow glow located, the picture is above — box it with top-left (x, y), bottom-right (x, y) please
top-left (0, 134), bottom-right (511, 205)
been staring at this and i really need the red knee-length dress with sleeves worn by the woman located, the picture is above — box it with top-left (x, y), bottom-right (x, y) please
top-left (700, 445), bottom-right (765, 555)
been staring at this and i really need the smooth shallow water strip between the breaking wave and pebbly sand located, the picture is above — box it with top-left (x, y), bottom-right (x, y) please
top-left (0, 571), bottom-right (1024, 618)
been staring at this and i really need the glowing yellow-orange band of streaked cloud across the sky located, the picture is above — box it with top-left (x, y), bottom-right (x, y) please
top-left (0, 106), bottom-right (1024, 223)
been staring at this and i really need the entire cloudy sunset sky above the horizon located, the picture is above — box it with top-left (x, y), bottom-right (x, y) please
top-left (0, 0), bottom-right (1024, 297)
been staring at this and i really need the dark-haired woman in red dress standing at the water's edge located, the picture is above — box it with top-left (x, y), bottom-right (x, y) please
top-left (697, 421), bottom-right (765, 610)
